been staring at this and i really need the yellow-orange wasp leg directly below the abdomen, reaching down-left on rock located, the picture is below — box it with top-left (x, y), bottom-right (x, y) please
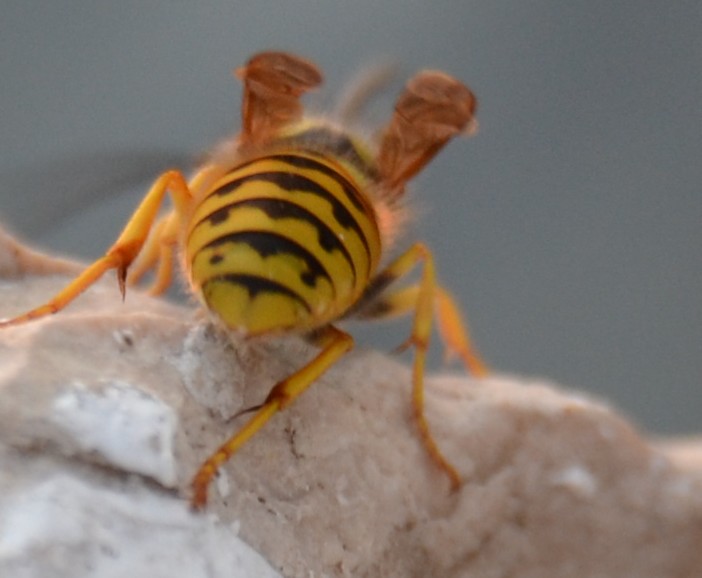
top-left (191, 325), bottom-right (353, 509)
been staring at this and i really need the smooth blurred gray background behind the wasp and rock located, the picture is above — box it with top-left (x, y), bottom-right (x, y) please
top-left (0, 0), bottom-right (702, 433)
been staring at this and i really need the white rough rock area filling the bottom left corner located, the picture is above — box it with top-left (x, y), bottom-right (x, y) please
top-left (0, 462), bottom-right (280, 578)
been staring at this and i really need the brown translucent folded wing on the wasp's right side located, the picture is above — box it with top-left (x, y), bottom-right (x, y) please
top-left (378, 70), bottom-right (477, 196)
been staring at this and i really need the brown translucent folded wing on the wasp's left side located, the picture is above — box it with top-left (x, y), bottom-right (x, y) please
top-left (236, 52), bottom-right (322, 144)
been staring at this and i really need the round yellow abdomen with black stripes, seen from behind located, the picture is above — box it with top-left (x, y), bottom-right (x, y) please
top-left (185, 151), bottom-right (380, 334)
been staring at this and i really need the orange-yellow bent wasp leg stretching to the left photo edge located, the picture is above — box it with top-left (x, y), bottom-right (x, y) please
top-left (0, 171), bottom-right (192, 327)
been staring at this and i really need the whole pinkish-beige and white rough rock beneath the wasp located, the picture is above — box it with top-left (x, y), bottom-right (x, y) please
top-left (0, 227), bottom-right (702, 578)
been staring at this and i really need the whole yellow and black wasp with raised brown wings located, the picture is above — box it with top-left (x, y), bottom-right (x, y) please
top-left (0, 52), bottom-right (486, 508)
